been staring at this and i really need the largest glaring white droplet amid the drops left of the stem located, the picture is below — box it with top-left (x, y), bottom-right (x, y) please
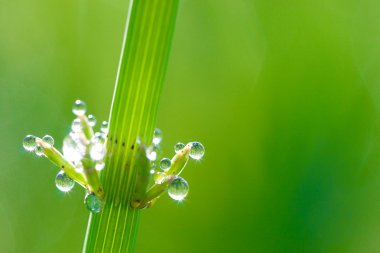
top-left (62, 134), bottom-right (86, 162)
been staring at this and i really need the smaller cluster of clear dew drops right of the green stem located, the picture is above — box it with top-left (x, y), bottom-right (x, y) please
top-left (147, 128), bottom-right (205, 201)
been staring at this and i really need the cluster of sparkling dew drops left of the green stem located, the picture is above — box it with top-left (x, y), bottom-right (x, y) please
top-left (23, 100), bottom-right (108, 212)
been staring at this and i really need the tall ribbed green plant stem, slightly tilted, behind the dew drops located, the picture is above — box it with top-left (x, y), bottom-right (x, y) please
top-left (83, 0), bottom-right (179, 253)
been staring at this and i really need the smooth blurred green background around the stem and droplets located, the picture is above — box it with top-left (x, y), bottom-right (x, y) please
top-left (0, 0), bottom-right (380, 253)
